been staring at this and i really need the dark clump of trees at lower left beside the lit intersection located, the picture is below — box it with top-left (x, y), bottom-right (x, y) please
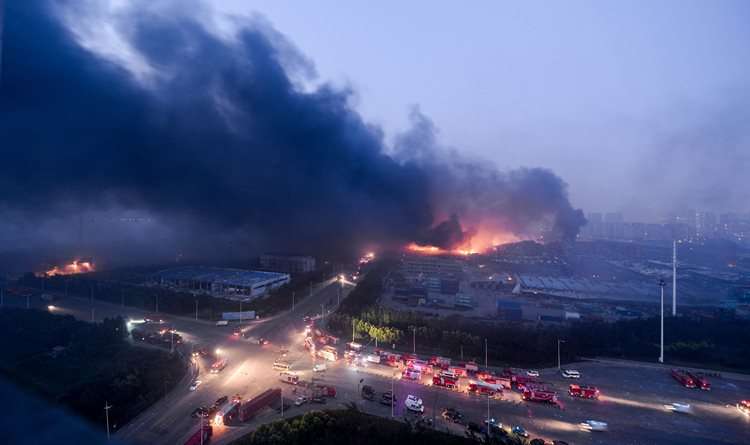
top-left (0, 308), bottom-right (186, 429)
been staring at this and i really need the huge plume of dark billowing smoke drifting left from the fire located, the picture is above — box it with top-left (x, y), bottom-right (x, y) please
top-left (0, 0), bottom-right (581, 260)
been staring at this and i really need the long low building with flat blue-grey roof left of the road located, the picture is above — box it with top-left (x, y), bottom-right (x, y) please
top-left (156, 266), bottom-right (290, 300)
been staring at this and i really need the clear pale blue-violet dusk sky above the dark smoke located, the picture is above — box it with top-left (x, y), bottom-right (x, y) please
top-left (215, 0), bottom-right (750, 218)
